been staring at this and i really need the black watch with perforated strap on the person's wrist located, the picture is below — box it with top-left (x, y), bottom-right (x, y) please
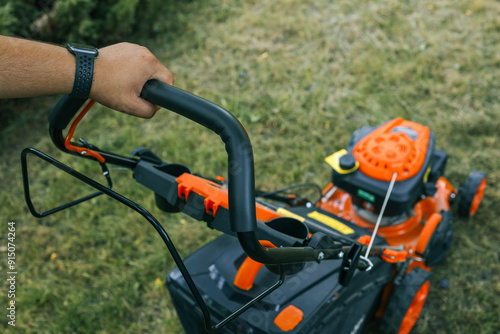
top-left (66, 44), bottom-right (99, 99)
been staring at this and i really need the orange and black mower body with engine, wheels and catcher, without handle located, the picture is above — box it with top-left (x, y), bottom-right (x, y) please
top-left (167, 118), bottom-right (486, 333)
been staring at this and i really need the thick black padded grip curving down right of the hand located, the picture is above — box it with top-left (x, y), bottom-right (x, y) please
top-left (141, 80), bottom-right (257, 232)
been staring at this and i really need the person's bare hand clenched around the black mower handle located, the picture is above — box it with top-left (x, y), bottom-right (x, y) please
top-left (90, 43), bottom-right (174, 118)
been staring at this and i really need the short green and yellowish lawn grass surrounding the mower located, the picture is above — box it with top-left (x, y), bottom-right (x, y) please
top-left (0, 0), bottom-right (500, 333)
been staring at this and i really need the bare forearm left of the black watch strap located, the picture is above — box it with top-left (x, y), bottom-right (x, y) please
top-left (0, 36), bottom-right (76, 98)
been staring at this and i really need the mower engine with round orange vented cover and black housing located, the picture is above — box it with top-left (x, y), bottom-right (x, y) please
top-left (326, 118), bottom-right (448, 226)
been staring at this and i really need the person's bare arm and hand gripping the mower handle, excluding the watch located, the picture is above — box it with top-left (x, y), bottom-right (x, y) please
top-left (0, 36), bottom-right (174, 118)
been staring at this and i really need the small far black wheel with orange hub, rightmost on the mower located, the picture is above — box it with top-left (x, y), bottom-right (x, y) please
top-left (458, 170), bottom-right (486, 218)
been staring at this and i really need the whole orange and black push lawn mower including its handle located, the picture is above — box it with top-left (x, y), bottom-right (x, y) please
top-left (21, 80), bottom-right (487, 334)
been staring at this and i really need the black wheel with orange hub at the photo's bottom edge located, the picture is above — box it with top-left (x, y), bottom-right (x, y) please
top-left (380, 267), bottom-right (431, 334)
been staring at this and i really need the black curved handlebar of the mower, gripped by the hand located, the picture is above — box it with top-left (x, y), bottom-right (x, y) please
top-left (49, 80), bottom-right (339, 264)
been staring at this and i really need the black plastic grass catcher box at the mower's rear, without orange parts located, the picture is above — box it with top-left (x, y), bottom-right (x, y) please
top-left (166, 235), bottom-right (393, 334)
